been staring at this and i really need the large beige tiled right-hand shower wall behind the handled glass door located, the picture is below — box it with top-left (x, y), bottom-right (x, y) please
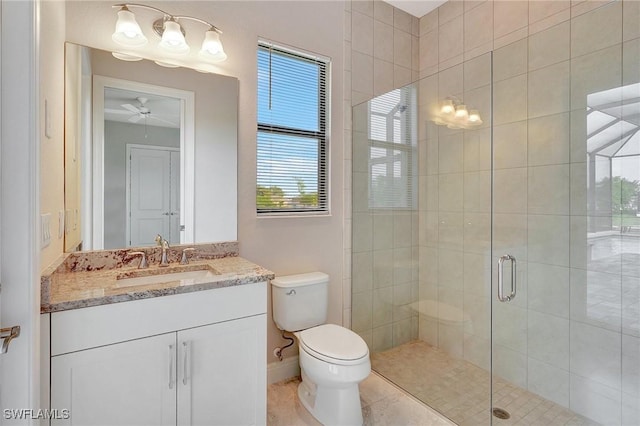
top-left (419, 1), bottom-right (640, 424)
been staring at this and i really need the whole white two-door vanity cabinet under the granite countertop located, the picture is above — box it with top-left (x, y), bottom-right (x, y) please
top-left (51, 282), bottom-right (267, 425)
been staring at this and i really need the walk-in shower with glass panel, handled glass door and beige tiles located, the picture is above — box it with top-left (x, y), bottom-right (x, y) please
top-left (352, 1), bottom-right (640, 425)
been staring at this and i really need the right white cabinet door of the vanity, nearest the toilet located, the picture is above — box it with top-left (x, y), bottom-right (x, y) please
top-left (178, 314), bottom-right (267, 426)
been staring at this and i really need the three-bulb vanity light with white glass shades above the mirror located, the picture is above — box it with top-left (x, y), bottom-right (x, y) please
top-left (111, 3), bottom-right (227, 62)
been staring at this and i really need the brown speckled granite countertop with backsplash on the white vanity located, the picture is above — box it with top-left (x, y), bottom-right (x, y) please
top-left (40, 243), bottom-right (274, 313)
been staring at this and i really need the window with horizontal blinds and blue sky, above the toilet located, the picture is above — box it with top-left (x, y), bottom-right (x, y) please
top-left (256, 42), bottom-right (329, 214)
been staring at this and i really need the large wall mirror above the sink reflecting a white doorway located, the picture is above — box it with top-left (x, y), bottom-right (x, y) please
top-left (65, 43), bottom-right (238, 251)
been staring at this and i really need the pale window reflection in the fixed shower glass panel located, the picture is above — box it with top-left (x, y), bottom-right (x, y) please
top-left (369, 86), bottom-right (417, 209)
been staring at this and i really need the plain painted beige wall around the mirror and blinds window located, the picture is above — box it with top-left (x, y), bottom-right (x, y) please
top-left (40, 1), bottom-right (350, 362)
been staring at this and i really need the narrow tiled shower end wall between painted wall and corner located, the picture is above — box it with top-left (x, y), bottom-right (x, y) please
top-left (343, 0), bottom-right (419, 350)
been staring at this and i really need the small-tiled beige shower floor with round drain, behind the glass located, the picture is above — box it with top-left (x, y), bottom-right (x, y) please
top-left (371, 341), bottom-right (598, 426)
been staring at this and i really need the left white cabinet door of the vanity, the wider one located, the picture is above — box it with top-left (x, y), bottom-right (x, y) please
top-left (51, 333), bottom-right (177, 426)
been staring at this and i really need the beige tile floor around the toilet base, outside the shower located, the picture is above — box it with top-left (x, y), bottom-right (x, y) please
top-left (267, 372), bottom-right (453, 426)
